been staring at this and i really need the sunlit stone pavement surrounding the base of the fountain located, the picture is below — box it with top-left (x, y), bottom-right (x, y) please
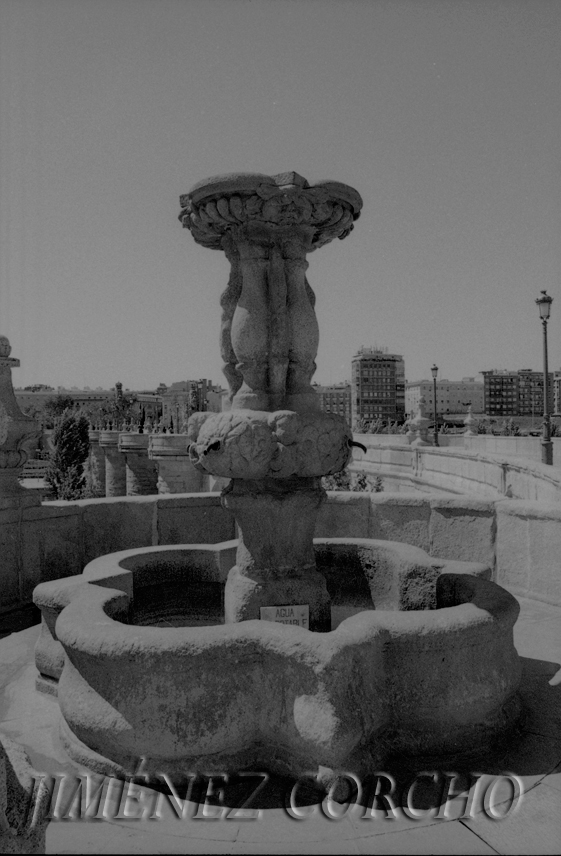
top-left (0, 599), bottom-right (561, 854)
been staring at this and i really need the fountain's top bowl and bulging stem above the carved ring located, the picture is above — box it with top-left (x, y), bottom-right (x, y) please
top-left (179, 172), bottom-right (362, 412)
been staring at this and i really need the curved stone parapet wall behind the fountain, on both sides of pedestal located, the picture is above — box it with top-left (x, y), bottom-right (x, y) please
top-left (0, 490), bottom-right (561, 612)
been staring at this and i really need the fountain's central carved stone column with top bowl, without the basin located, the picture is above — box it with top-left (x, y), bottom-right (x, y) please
top-left (180, 172), bottom-right (362, 630)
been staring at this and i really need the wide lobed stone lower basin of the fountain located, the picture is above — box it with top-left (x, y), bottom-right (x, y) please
top-left (30, 539), bottom-right (520, 775)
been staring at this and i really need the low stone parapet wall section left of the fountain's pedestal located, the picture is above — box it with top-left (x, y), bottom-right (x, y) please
top-left (0, 493), bottom-right (235, 612)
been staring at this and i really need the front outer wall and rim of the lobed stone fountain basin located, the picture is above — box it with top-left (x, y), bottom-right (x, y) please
top-left (48, 564), bottom-right (520, 776)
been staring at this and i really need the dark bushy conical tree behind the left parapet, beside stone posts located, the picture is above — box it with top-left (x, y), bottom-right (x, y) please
top-left (45, 412), bottom-right (90, 499)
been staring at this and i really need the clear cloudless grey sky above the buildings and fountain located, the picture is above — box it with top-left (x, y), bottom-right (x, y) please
top-left (0, 0), bottom-right (561, 389)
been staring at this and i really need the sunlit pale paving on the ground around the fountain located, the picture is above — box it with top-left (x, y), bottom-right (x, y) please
top-left (0, 599), bottom-right (561, 856)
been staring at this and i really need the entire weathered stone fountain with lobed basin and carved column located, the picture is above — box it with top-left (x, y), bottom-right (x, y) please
top-left (30, 173), bottom-right (520, 781)
